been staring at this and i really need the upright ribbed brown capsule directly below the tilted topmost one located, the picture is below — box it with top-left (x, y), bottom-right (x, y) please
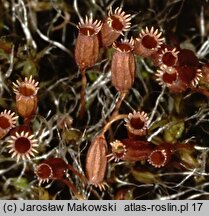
top-left (111, 39), bottom-right (136, 93)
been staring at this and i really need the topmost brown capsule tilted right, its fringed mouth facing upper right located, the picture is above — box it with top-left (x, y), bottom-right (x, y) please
top-left (101, 7), bottom-right (131, 47)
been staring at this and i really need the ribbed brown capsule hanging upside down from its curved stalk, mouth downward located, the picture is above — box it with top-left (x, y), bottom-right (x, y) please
top-left (86, 135), bottom-right (107, 190)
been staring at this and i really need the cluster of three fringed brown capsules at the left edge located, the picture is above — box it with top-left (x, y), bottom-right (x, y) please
top-left (0, 77), bottom-right (39, 161)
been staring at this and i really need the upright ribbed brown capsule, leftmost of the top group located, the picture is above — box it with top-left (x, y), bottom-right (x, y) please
top-left (75, 17), bottom-right (102, 70)
